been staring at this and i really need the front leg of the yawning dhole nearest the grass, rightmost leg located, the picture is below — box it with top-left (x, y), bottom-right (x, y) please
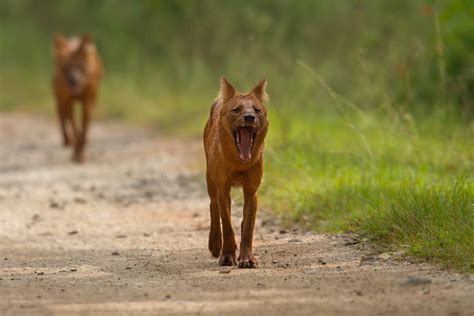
top-left (239, 189), bottom-right (258, 268)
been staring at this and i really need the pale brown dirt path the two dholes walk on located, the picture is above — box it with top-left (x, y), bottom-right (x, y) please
top-left (0, 113), bottom-right (474, 315)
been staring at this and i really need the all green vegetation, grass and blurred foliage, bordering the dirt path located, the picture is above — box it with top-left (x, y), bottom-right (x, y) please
top-left (0, 0), bottom-right (474, 271)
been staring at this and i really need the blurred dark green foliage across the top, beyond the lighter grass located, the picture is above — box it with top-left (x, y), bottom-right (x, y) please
top-left (0, 0), bottom-right (474, 115)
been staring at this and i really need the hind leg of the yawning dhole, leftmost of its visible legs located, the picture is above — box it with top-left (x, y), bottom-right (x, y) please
top-left (206, 173), bottom-right (222, 258)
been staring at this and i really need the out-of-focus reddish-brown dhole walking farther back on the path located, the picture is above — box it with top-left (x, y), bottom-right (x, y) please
top-left (53, 34), bottom-right (102, 162)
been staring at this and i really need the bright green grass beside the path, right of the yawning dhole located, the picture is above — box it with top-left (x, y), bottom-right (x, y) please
top-left (263, 105), bottom-right (474, 271)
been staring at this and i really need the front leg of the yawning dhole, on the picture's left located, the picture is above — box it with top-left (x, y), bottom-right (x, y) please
top-left (218, 187), bottom-right (237, 266)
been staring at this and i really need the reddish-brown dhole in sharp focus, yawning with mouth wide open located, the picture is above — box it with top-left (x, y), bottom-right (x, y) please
top-left (204, 78), bottom-right (268, 268)
